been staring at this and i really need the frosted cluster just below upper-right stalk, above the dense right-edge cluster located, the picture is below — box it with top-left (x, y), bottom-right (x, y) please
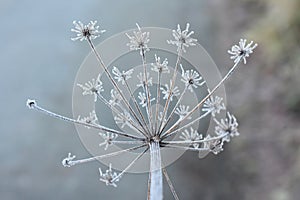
top-left (202, 96), bottom-right (226, 117)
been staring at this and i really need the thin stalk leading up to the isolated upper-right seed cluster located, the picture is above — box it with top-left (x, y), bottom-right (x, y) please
top-left (165, 60), bottom-right (240, 135)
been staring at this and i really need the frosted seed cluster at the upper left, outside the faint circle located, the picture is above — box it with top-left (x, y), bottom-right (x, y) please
top-left (71, 21), bottom-right (105, 41)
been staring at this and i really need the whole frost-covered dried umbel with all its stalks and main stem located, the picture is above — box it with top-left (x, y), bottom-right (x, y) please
top-left (26, 21), bottom-right (257, 200)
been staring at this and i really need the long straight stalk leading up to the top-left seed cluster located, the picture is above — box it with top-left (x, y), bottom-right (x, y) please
top-left (87, 38), bottom-right (147, 136)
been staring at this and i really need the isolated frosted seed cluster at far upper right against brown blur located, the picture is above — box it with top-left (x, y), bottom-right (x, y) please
top-left (228, 39), bottom-right (257, 64)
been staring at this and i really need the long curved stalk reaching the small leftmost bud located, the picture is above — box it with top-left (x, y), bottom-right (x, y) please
top-left (31, 104), bottom-right (144, 141)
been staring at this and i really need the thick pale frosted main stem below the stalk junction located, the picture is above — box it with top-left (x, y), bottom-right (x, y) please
top-left (150, 142), bottom-right (163, 200)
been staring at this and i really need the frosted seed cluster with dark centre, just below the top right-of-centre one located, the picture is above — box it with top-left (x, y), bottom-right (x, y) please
top-left (180, 65), bottom-right (205, 92)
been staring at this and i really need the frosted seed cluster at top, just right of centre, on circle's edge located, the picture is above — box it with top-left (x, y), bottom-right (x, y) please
top-left (167, 23), bottom-right (197, 52)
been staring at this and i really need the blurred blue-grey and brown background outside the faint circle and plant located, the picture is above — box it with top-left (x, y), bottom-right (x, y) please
top-left (0, 0), bottom-right (300, 200)
